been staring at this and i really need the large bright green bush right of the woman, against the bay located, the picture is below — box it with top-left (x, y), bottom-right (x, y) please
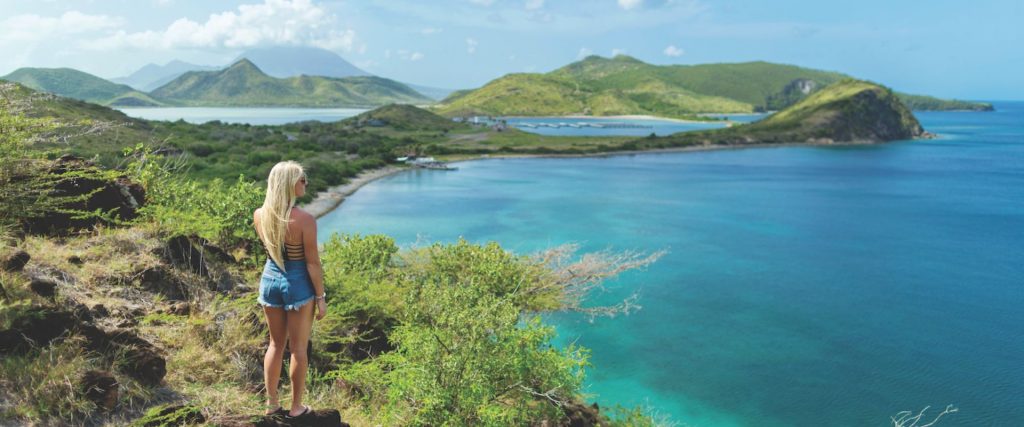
top-left (333, 240), bottom-right (588, 426)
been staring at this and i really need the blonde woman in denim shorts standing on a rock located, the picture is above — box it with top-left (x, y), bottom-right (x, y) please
top-left (253, 161), bottom-right (327, 418)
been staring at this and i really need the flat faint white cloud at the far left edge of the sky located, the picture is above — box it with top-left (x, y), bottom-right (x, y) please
top-left (0, 10), bottom-right (122, 42)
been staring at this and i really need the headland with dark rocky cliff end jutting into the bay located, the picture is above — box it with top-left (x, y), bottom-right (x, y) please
top-left (662, 79), bottom-right (926, 146)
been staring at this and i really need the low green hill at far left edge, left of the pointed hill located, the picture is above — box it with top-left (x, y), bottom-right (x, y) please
top-left (2, 68), bottom-right (163, 106)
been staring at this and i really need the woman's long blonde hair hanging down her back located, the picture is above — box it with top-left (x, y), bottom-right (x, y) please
top-left (256, 161), bottom-right (305, 270)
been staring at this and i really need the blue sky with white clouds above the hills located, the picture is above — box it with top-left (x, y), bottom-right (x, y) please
top-left (0, 0), bottom-right (1024, 100)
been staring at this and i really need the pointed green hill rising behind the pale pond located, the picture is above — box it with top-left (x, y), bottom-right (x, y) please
top-left (152, 59), bottom-right (431, 108)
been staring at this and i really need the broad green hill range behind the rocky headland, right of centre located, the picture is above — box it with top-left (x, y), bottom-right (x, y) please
top-left (437, 55), bottom-right (991, 118)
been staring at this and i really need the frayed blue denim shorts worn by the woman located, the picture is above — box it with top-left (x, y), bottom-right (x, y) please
top-left (258, 259), bottom-right (313, 310)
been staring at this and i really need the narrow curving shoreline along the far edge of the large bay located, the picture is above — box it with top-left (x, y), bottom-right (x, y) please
top-left (300, 141), bottom-right (905, 218)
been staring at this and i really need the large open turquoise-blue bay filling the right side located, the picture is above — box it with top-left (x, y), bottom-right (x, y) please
top-left (319, 102), bottom-right (1024, 427)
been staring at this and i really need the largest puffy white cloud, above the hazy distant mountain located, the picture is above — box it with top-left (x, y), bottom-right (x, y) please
top-left (90, 0), bottom-right (366, 52)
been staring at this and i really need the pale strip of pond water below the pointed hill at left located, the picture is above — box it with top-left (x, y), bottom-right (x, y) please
top-left (118, 106), bottom-right (367, 125)
